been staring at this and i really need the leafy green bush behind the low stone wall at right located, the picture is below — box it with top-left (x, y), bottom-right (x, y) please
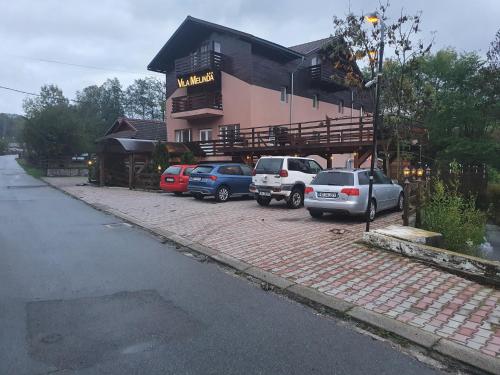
top-left (422, 180), bottom-right (486, 256)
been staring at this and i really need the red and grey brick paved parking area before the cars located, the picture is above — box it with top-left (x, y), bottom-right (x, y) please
top-left (48, 178), bottom-right (500, 358)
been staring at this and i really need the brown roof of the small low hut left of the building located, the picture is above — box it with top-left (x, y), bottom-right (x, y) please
top-left (101, 117), bottom-right (167, 141)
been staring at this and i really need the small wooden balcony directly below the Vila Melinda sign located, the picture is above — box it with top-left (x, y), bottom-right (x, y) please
top-left (172, 92), bottom-right (224, 120)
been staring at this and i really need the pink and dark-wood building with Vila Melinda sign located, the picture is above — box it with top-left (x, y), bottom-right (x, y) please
top-left (148, 16), bottom-right (371, 163)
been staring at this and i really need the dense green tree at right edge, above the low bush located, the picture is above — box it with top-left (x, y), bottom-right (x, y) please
top-left (413, 49), bottom-right (500, 168)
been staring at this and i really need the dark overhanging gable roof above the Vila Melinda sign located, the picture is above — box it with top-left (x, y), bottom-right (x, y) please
top-left (148, 16), bottom-right (302, 73)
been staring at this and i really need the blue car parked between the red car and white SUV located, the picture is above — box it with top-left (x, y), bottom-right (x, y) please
top-left (188, 163), bottom-right (252, 202)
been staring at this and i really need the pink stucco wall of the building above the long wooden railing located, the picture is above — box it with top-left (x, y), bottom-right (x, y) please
top-left (167, 72), bottom-right (359, 141)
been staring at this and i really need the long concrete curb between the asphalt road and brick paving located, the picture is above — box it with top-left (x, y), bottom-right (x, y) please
top-left (43, 180), bottom-right (500, 375)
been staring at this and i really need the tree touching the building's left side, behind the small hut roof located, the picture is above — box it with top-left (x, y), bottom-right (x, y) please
top-left (125, 77), bottom-right (165, 120)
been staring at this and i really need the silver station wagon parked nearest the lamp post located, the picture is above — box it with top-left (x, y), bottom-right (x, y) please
top-left (304, 169), bottom-right (404, 221)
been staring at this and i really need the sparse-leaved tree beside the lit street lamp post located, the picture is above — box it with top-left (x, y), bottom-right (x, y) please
top-left (321, 3), bottom-right (432, 177)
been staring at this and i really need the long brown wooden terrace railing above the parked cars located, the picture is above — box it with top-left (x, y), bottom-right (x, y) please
top-left (186, 116), bottom-right (373, 156)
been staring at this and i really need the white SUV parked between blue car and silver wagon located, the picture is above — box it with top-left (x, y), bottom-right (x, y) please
top-left (250, 156), bottom-right (322, 208)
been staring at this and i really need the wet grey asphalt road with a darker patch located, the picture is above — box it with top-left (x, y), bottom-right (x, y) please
top-left (0, 156), bottom-right (446, 375)
